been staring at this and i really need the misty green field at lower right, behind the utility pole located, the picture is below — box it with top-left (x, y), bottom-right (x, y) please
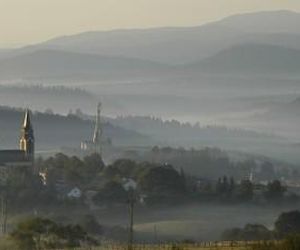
top-left (95, 204), bottom-right (297, 243)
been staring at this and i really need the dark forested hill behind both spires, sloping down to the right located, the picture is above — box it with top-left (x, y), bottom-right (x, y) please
top-left (0, 107), bottom-right (150, 150)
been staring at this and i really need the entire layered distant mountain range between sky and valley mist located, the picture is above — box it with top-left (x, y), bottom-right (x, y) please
top-left (0, 11), bottom-right (300, 80)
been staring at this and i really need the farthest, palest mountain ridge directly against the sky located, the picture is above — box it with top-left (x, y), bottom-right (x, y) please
top-left (0, 11), bottom-right (300, 65)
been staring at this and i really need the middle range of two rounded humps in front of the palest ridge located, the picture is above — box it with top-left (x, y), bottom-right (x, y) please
top-left (0, 44), bottom-right (300, 81)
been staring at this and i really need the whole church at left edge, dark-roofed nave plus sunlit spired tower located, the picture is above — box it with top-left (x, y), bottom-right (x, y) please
top-left (0, 109), bottom-right (34, 172)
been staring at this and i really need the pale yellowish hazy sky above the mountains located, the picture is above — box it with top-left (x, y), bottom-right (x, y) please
top-left (0, 0), bottom-right (300, 47)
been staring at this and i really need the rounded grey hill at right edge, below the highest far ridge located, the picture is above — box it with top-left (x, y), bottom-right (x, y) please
top-left (187, 44), bottom-right (300, 75)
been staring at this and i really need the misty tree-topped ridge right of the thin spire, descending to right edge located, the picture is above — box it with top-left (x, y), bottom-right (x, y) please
top-left (107, 116), bottom-right (299, 164)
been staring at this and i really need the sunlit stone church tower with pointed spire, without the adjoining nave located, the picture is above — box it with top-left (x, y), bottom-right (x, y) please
top-left (20, 109), bottom-right (34, 161)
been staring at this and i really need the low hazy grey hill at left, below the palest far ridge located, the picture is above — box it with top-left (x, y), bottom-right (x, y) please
top-left (0, 50), bottom-right (169, 79)
